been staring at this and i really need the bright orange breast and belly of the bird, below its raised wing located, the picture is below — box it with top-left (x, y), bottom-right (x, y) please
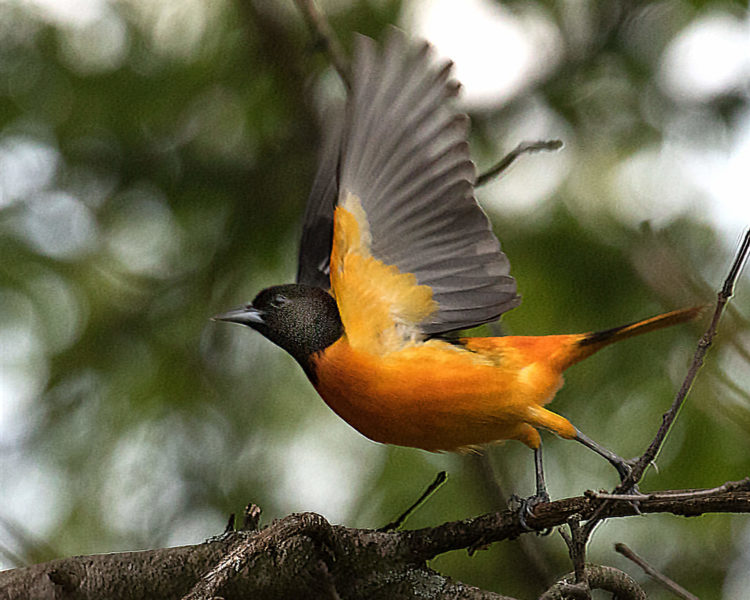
top-left (313, 338), bottom-right (575, 450)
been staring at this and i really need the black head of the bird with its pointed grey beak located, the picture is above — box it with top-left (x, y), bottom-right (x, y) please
top-left (214, 284), bottom-right (344, 375)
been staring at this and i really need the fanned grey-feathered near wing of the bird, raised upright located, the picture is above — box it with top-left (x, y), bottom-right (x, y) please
top-left (301, 29), bottom-right (520, 338)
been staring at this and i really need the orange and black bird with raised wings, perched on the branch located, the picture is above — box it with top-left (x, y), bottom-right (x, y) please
top-left (215, 30), bottom-right (700, 504)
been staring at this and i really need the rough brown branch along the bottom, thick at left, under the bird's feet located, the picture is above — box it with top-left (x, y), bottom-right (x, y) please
top-left (0, 488), bottom-right (750, 600)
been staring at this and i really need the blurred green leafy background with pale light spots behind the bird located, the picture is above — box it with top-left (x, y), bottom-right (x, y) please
top-left (0, 0), bottom-right (750, 600)
